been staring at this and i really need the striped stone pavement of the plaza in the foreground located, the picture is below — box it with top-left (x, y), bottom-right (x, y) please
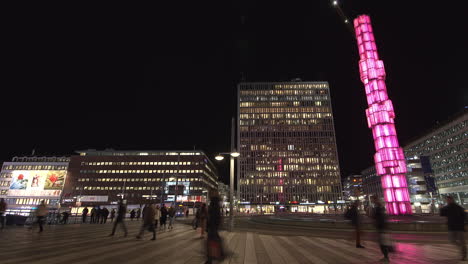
top-left (0, 221), bottom-right (468, 264)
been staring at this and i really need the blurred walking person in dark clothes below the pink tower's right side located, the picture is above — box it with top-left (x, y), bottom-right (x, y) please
top-left (371, 196), bottom-right (393, 262)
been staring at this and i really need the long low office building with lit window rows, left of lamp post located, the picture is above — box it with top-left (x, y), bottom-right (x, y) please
top-left (64, 149), bottom-right (218, 211)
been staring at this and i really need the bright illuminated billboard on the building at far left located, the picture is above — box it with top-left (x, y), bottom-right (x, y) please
top-left (8, 170), bottom-right (67, 196)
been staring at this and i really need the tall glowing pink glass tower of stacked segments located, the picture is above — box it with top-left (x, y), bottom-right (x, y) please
top-left (354, 15), bottom-right (411, 215)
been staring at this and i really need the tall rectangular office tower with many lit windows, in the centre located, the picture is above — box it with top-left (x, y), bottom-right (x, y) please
top-left (238, 81), bottom-right (342, 213)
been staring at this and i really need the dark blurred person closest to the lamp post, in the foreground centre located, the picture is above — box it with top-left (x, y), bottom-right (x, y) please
top-left (205, 191), bottom-right (224, 264)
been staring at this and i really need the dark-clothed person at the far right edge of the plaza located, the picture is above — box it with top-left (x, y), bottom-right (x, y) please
top-left (440, 196), bottom-right (466, 261)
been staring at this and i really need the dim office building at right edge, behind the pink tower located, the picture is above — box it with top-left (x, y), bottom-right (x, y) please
top-left (404, 109), bottom-right (468, 205)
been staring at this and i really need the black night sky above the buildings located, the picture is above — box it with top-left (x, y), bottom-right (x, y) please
top-left (0, 0), bottom-right (468, 185)
